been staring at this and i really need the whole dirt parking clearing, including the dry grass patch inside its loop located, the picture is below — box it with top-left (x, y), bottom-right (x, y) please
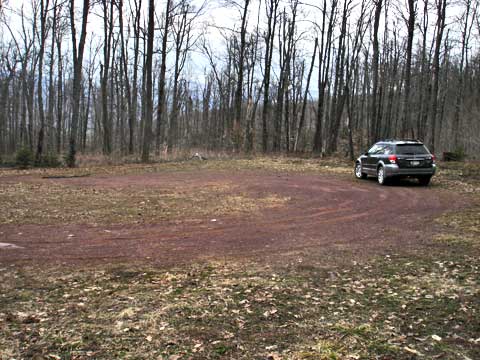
top-left (0, 162), bottom-right (468, 267)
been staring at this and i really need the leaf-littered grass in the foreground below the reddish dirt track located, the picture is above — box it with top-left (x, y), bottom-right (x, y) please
top-left (0, 253), bottom-right (480, 360)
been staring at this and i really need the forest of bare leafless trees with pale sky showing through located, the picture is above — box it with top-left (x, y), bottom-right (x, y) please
top-left (0, 0), bottom-right (480, 166)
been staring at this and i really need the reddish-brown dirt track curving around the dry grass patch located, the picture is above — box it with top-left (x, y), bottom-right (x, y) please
top-left (0, 170), bottom-right (468, 267)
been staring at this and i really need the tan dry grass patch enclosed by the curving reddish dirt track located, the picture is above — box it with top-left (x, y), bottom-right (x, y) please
top-left (0, 182), bottom-right (289, 224)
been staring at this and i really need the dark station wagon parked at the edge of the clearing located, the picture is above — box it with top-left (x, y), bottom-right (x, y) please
top-left (355, 140), bottom-right (436, 186)
